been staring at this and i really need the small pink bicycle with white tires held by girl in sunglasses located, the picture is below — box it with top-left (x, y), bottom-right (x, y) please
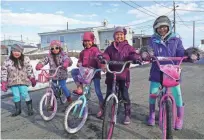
top-left (38, 66), bottom-right (67, 121)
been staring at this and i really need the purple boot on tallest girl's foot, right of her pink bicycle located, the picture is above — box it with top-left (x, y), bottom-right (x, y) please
top-left (175, 106), bottom-right (184, 130)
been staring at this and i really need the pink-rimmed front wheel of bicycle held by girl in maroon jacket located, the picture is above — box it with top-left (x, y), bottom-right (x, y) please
top-left (102, 97), bottom-right (117, 139)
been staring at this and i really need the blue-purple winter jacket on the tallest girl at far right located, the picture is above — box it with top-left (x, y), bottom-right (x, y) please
top-left (149, 35), bottom-right (185, 82)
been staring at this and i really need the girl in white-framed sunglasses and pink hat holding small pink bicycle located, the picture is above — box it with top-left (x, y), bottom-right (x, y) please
top-left (36, 40), bottom-right (72, 103)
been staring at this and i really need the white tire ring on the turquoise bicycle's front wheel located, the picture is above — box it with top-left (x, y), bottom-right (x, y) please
top-left (64, 100), bottom-right (88, 134)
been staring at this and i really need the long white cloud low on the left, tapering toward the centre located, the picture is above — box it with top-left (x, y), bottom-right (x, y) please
top-left (1, 9), bottom-right (101, 26)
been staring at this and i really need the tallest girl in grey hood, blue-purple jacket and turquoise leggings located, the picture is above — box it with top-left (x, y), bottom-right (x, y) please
top-left (145, 16), bottom-right (197, 130)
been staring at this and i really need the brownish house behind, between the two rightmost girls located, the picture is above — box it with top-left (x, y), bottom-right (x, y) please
top-left (133, 34), bottom-right (151, 48)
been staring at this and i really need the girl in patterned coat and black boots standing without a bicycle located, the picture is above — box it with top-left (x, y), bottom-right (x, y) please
top-left (1, 44), bottom-right (36, 117)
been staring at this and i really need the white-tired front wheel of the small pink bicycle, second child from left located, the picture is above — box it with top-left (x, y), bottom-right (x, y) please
top-left (39, 93), bottom-right (57, 121)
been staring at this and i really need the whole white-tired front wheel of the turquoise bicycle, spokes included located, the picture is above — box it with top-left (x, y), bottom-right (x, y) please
top-left (64, 100), bottom-right (88, 133)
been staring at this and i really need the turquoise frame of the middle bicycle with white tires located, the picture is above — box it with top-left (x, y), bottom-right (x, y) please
top-left (72, 69), bottom-right (101, 117)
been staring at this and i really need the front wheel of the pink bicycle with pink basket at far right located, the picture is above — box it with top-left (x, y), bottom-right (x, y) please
top-left (162, 100), bottom-right (173, 139)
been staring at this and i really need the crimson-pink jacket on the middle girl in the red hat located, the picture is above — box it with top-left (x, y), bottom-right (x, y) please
top-left (78, 46), bottom-right (102, 78)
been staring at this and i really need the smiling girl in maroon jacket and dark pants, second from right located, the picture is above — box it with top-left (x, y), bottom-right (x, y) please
top-left (99, 27), bottom-right (140, 124)
